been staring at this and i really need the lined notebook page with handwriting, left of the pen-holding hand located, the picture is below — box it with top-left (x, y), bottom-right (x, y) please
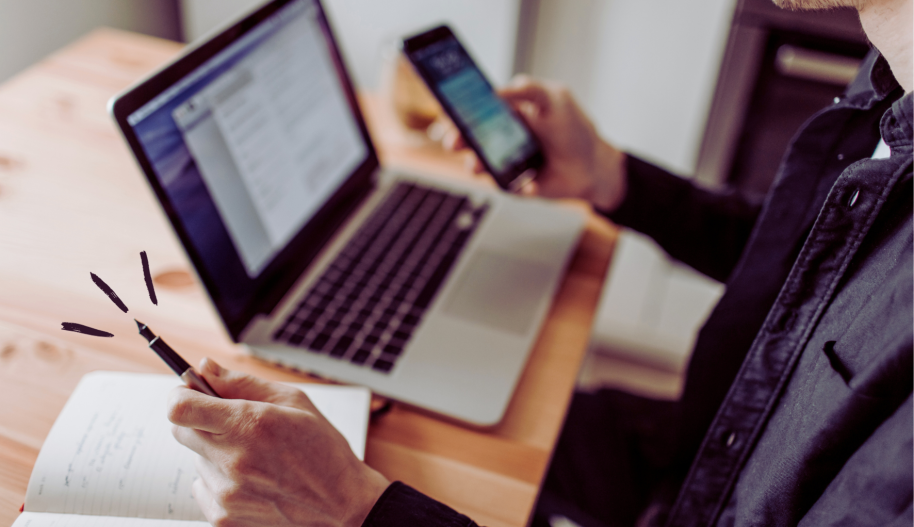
top-left (25, 372), bottom-right (204, 521)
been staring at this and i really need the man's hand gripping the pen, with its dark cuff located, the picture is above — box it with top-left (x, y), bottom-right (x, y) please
top-left (168, 359), bottom-right (476, 527)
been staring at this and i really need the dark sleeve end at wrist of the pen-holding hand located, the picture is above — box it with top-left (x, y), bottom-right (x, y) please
top-left (362, 481), bottom-right (478, 527)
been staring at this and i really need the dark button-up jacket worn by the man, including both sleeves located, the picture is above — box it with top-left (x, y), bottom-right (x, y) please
top-left (365, 50), bottom-right (914, 527)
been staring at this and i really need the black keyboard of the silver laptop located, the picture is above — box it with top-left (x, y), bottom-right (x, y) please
top-left (273, 183), bottom-right (488, 373)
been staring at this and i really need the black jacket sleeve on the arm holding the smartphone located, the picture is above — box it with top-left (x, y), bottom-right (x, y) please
top-left (606, 155), bottom-right (761, 282)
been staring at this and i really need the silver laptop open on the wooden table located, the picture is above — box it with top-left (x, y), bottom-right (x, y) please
top-left (109, 0), bottom-right (584, 426)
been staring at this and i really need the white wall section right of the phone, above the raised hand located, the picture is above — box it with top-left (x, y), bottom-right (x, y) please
top-left (529, 0), bottom-right (736, 175)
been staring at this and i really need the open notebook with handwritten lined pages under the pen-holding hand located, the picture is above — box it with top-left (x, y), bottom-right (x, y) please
top-left (13, 372), bottom-right (371, 527)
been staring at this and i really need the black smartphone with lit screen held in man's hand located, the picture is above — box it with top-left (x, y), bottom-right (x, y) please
top-left (402, 26), bottom-right (545, 191)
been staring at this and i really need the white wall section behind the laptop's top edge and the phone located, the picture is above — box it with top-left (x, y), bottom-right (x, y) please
top-left (182, 0), bottom-right (520, 89)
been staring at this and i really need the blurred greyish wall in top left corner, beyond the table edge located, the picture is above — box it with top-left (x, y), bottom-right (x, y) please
top-left (0, 0), bottom-right (180, 82)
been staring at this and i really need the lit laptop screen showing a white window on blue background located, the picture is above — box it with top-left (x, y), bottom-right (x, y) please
top-left (115, 0), bottom-right (376, 334)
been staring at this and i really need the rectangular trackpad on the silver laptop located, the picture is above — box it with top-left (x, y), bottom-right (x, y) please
top-left (444, 251), bottom-right (553, 335)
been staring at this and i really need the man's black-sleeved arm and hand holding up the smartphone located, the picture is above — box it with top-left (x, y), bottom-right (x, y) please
top-left (454, 76), bottom-right (761, 281)
